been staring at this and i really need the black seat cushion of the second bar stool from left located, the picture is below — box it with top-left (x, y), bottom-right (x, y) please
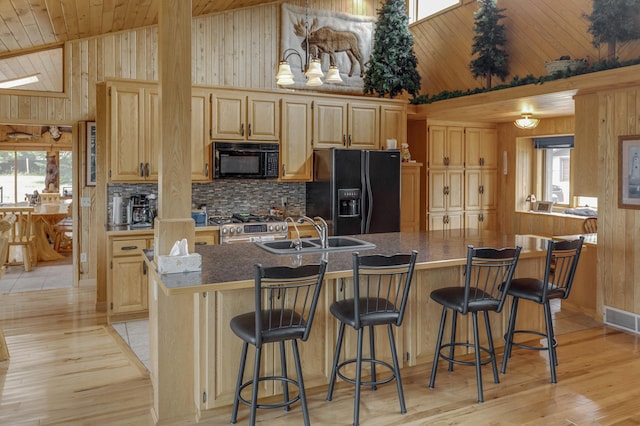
top-left (329, 298), bottom-right (398, 328)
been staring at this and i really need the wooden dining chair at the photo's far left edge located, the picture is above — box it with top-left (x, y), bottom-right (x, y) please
top-left (0, 207), bottom-right (38, 272)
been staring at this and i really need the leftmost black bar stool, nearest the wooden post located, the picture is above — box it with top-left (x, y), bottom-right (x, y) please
top-left (231, 261), bottom-right (327, 426)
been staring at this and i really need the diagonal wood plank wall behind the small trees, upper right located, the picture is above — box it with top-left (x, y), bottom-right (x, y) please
top-left (410, 0), bottom-right (640, 95)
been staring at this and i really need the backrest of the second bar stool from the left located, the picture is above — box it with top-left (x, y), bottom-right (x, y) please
top-left (353, 250), bottom-right (418, 328)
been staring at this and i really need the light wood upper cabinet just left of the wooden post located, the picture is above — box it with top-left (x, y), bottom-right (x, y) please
top-left (107, 82), bottom-right (160, 182)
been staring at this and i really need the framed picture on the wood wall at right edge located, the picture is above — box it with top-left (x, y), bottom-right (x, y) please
top-left (618, 135), bottom-right (640, 209)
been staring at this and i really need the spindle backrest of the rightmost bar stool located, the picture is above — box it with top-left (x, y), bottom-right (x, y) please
top-left (541, 235), bottom-right (584, 302)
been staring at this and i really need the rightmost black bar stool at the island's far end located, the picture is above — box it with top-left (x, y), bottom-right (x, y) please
top-left (500, 236), bottom-right (584, 383)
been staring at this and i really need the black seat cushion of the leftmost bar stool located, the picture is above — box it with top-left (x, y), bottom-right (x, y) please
top-left (230, 309), bottom-right (307, 345)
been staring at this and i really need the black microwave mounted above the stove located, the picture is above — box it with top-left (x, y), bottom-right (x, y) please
top-left (211, 142), bottom-right (280, 179)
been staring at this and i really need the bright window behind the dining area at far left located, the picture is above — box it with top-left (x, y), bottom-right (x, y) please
top-left (0, 151), bottom-right (72, 203)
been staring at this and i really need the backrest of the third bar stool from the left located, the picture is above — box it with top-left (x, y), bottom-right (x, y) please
top-left (461, 246), bottom-right (521, 314)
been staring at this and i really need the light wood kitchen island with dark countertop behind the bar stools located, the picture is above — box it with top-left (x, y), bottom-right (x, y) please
top-left (148, 230), bottom-right (546, 423)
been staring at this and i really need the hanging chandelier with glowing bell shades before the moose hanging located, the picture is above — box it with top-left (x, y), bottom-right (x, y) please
top-left (276, 0), bottom-right (342, 86)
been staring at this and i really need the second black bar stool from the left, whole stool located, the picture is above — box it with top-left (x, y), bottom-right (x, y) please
top-left (327, 250), bottom-right (418, 425)
